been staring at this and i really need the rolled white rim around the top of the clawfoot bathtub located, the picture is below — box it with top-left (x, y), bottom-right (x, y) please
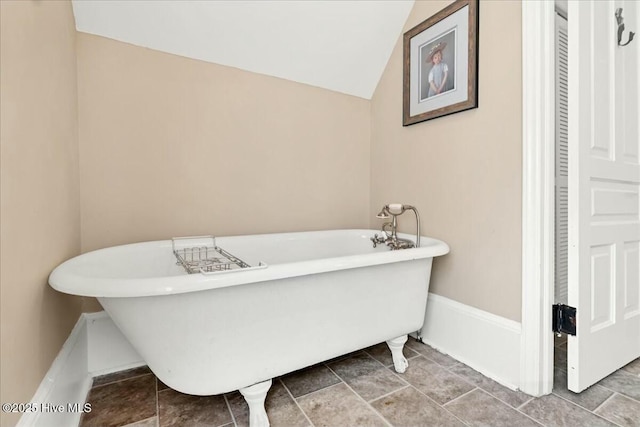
top-left (49, 229), bottom-right (449, 298)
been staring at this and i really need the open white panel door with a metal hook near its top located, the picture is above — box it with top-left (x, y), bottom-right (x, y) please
top-left (568, 0), bottom-right (640, 392)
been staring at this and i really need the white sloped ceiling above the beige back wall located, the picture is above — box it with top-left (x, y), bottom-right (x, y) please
top-left (73, 0), bottom-right (414, 99)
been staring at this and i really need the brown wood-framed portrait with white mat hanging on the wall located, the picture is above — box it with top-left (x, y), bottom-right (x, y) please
top-left (402, 0), bottom-right (478, 126)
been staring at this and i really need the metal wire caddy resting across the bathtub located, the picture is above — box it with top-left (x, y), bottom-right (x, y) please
top-left (171, 236), bottom-right (267, 274)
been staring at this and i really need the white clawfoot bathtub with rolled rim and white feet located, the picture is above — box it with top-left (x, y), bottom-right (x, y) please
top-left (49, 230), bottom-right (449, 426)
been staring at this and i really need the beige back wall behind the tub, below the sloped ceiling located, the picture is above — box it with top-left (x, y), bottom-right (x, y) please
top-left (78, 33), bottom-right (370, 251)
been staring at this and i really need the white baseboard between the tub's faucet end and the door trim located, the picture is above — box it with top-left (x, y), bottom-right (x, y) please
top-left (422, 293), bottom-right (521, 390)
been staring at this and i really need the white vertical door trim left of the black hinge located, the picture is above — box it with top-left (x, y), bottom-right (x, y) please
top-left (520, 1), bottom-right (555, 396)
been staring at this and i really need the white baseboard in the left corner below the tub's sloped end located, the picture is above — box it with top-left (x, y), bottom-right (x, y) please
top-left (17, 312), bottom-right (144, 427)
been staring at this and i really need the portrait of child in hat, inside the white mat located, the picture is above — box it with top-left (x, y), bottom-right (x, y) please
top-left (420, 33), bottom-right (455, 100)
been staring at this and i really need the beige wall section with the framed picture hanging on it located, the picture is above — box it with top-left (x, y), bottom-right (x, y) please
top-left (371, 1), bottom-right (522, 321)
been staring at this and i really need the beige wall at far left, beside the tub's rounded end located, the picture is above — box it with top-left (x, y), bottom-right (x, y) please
top-left (0, 0), bottom-right (81, 426)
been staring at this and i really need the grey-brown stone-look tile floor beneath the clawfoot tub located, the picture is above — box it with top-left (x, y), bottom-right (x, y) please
top-left (80, 339), bottom-right (640, 427)
